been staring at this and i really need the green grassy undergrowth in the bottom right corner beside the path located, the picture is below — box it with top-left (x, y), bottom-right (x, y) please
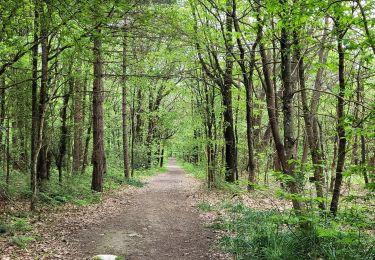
top-left (210, 203), bottom-right (375, 260)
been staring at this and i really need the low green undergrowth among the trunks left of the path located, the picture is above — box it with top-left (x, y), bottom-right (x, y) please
top-left (0, 167), bottom-right (166, 208)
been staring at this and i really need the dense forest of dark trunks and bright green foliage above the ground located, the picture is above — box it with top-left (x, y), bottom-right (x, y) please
top-left (0, 0), bottom-right (375, 259)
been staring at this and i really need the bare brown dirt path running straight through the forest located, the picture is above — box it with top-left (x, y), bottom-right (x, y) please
top-left (74, 159), bottom-right (223, 260)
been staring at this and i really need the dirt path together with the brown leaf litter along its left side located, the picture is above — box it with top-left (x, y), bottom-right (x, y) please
top-left (0, 159), bottom-right (229, 260)
